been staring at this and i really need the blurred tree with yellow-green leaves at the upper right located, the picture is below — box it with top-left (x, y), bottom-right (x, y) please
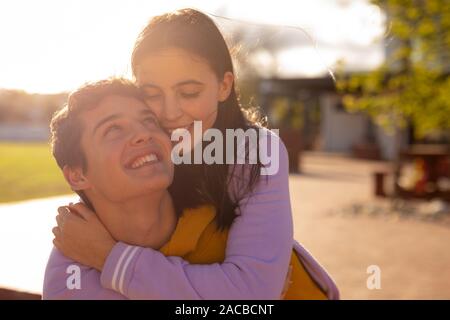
top-left (337, 0), bottom-right (450, 138)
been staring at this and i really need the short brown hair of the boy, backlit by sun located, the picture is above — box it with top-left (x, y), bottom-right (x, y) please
top-left (50, 78), bottom-right (145, 171)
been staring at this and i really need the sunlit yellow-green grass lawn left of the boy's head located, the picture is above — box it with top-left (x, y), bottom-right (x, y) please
top-left (0, 142), bottom-right (71, 202)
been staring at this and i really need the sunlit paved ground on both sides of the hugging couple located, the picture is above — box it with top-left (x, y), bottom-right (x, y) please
top-left (0, 153), bottom-right (450, 299)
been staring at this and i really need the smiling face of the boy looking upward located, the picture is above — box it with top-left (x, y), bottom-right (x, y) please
top-left (67, 95), bottom-right (173, 202)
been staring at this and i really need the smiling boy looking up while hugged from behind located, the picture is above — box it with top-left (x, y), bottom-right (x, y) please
top-left (43, 79), bottom-right (177, 299)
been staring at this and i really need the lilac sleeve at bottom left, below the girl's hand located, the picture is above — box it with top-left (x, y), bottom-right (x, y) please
top-left (42, 248), bottom-right (126, 300)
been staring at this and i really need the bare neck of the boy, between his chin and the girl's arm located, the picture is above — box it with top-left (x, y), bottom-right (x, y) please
top-left (90, 190), bottom-right (177, 249)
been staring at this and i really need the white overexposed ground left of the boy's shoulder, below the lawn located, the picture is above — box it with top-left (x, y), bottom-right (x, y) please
top-left (0, 192), bottom-right (76, 293)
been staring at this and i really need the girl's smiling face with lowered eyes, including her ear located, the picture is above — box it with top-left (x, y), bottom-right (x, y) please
top-left (136, 48), bottom-right (233, 146)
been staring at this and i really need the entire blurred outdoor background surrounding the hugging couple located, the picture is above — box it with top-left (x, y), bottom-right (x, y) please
top-left (0, 0), bottom-right (450, 299)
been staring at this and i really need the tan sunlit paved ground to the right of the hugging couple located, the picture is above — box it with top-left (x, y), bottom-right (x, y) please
top-left (290, 154), bottom-right (450, 299)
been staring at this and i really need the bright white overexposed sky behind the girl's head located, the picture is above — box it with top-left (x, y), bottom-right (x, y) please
top-left (0, 0), bottom-right (384, 93)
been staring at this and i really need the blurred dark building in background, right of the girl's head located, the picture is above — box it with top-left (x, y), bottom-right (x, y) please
top-left (259, 77), bottom-right (411, 160)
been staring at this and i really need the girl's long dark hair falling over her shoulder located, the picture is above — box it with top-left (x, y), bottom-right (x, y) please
top-left (131, 9), bottom-right (261, 229)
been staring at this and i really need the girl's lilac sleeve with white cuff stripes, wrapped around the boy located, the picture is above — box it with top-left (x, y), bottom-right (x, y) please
top-left (101, 133), bottom-right (293, 299)
